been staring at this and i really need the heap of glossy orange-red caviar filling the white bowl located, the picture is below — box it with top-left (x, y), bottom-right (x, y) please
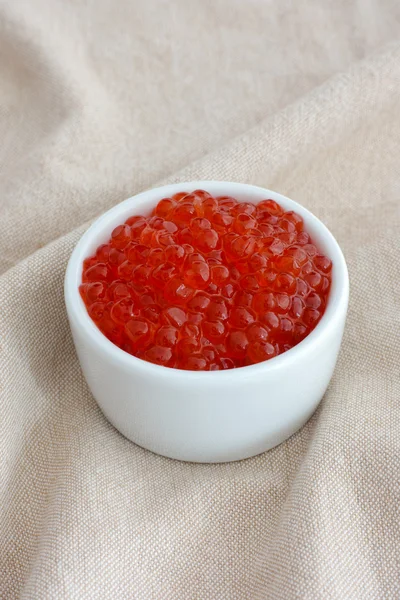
top-left (80, 190), bottom-right (332, 371)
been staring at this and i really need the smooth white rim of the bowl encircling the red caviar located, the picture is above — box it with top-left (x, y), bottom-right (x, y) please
top-left (64, 180), bottom-right (349, 382)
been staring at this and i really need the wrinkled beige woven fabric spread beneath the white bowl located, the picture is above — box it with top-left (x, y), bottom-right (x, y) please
top-left (0, 0), bottom-right (400, 600)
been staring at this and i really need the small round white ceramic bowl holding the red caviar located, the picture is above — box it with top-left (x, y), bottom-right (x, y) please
top-left (65, 181), bottom-right (349, 462)
